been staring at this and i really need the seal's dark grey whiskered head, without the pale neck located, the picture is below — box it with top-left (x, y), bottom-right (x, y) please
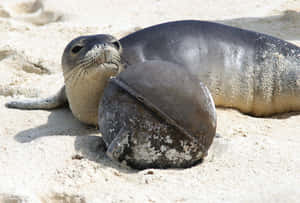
top-left (62, 35), bottom-right (122, 79)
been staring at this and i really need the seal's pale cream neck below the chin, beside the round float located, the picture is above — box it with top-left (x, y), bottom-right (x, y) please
top-left (65, 68), bottom-right (116, 125)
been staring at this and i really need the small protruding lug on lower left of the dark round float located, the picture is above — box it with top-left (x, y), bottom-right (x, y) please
top-left (106, 129), bottom-right (129, 162)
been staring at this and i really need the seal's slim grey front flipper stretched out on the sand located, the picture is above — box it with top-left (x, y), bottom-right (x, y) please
top-left (5, 86), bottom-right (68, 109)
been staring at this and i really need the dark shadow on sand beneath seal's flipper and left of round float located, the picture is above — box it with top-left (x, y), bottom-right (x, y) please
top-left (14, 108), bottom-right (135, 173)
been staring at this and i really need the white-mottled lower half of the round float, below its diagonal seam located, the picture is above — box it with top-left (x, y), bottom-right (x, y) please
top-left (99, 83), bottom-right (209, 169)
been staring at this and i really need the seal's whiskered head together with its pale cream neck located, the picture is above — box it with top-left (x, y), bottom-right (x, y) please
top-left (62, 35), bottom-right (122, 125)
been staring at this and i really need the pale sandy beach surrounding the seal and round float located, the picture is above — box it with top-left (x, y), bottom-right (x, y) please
top-left (0, 0), bottom-right (300, 203)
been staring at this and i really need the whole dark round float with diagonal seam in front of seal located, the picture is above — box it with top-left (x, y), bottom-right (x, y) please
top-left (98, 61), bottom-right (216, 169)
